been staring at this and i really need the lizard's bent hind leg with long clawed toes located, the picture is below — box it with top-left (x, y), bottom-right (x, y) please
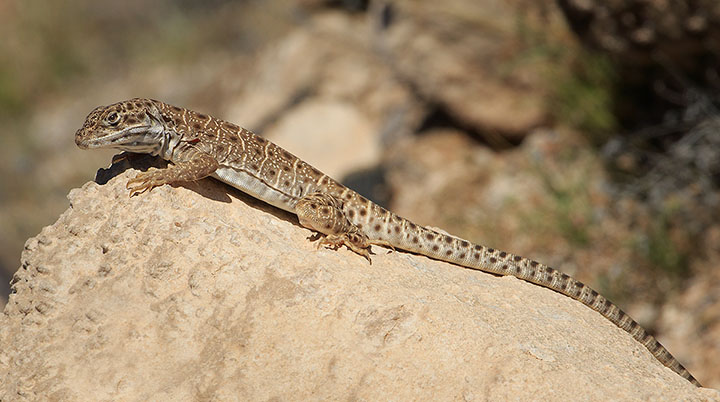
top-left (295, 192), bottom-right (372, 263)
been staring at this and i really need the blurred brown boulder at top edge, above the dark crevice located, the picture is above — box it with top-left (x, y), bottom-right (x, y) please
top-left (377, 0), bottom-right (559, 139)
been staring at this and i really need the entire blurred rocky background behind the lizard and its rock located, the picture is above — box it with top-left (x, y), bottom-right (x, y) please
top-left (0, 0), bottom-right (720, 387)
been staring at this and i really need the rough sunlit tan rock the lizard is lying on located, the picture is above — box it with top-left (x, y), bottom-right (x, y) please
top-left (0, 166), bottom-right (720, 401)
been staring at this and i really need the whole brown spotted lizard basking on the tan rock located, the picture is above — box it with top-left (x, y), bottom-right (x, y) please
top-left (75, 99), bottom-right (700, 386)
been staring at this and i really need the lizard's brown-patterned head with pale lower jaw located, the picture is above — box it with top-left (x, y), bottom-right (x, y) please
top-left (75, 98), bottom-right (164, 153)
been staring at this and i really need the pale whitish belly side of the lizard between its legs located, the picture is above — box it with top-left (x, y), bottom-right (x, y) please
top-left (212, 167), bottom-right (297, 213)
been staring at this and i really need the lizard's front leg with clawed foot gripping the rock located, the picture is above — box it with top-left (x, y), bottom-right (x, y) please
top-left (125, 151), bottom-right (220, 197)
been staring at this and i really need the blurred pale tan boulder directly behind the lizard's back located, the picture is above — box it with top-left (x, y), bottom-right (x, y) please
top-left (223, 13), bottom-right (425, 179)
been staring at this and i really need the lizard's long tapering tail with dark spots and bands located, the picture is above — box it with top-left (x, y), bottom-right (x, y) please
top-left (379, 213), bottom-right (701, 387)
